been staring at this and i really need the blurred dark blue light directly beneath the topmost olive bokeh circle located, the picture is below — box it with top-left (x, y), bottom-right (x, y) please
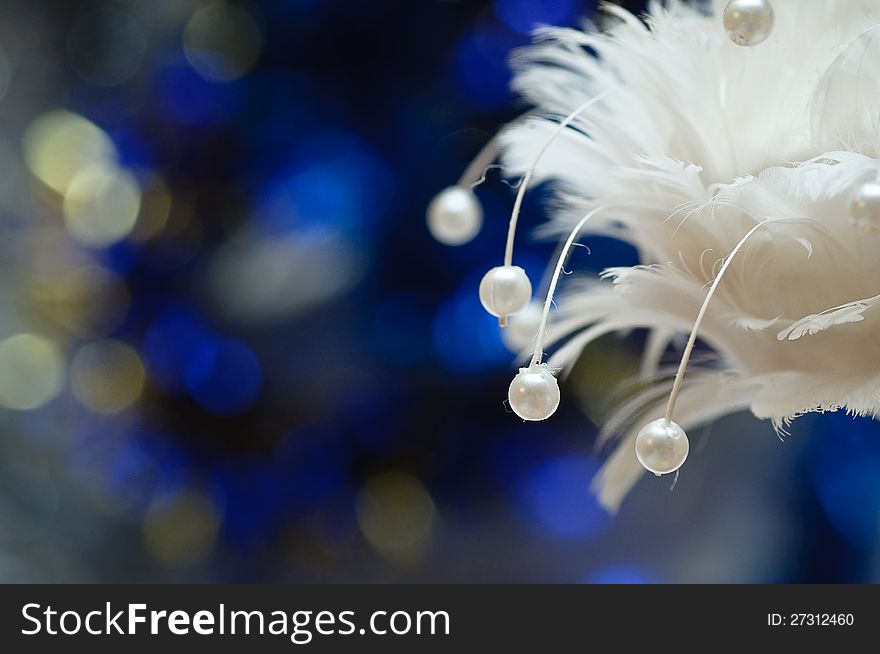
top-left (157, 61), bottom-right (242, 127)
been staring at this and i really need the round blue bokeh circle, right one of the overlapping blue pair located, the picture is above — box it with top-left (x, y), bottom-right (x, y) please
top-left (186, 338), bottom-right (263, 415)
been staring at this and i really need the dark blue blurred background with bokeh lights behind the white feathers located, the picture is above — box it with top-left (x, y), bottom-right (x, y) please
top-left (0, 0), bottom-right (880, 583)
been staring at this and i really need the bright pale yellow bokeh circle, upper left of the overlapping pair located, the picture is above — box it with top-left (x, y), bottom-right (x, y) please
top-left (22, 109), bottom-right (116, 193)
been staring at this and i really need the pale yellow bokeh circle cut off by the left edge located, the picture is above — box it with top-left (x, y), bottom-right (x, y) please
top-left (0, 334), bottom-right (64, 411)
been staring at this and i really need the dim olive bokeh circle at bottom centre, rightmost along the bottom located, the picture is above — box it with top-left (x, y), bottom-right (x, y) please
top-left (356, 472), bottom-right (436, 558)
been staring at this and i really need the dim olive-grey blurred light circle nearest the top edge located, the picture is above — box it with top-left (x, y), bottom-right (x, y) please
top-left (183, 1), bottom-right (263, 82)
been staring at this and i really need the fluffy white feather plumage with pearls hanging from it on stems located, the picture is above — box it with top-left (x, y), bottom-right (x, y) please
top-left (503, 0), bottom-right (880, 509)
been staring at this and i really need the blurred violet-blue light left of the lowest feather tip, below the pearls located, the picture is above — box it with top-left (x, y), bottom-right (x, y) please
top-left (519, 455), bottom-right (609, 539)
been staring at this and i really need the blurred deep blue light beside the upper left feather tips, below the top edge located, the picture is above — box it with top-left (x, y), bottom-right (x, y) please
top-left (455, 28), bottom-right (527, 109)
